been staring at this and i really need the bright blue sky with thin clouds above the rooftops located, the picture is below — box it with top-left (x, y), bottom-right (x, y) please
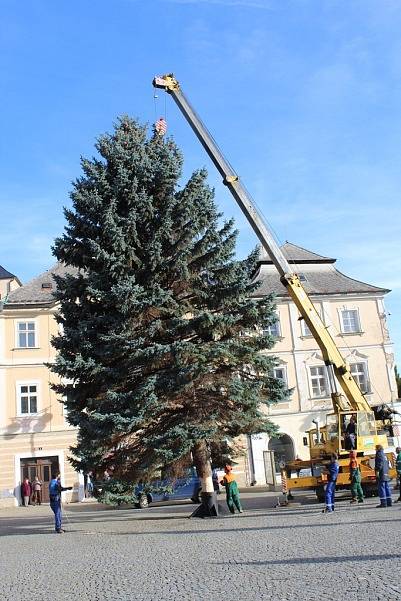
top-left (0, 0), bottom-right (401, 364)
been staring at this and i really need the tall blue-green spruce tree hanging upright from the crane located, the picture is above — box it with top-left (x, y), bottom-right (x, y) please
top-left (52, 117), bottom-right (287, 502)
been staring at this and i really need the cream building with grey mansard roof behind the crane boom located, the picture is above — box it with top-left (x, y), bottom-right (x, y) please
top-left (248, 243), bottom-right (397, 485)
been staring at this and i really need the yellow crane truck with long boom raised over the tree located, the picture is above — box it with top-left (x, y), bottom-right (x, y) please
top-left (153, 73), bottom-right (395, 500)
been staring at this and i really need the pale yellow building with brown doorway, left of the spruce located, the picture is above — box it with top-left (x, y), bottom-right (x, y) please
top-left (0, 267), bottom-right (83, 507)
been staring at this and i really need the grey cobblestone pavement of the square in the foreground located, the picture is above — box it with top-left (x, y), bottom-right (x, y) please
top-left (0, 493), bottom-right (401, 601)
